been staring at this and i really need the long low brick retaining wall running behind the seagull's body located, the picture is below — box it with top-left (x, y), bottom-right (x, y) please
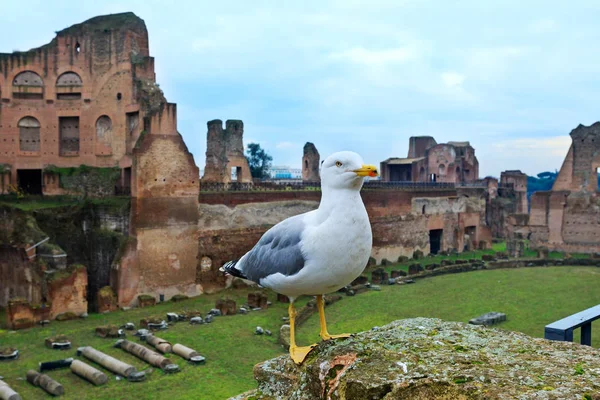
top-left (197, 190), bottom-right (491, 282)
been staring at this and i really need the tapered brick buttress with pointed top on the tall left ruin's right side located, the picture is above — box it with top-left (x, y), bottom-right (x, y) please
top-left (114, 105), bottom-right (202, 306)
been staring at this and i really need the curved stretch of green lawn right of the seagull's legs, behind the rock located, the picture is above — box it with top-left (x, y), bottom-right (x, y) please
top-left (299, 267), bottom-right (600, 347)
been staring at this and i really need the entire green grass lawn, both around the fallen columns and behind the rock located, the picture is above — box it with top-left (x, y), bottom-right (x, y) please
top-left (0, 267), bottom-right (600, 400)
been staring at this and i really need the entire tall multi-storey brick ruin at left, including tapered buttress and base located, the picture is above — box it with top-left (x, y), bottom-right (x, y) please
top-left (0, 13), bottom-right (202, 316)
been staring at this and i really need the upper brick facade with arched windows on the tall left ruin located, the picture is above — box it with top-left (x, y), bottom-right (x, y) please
top-left (0, 13), bottom-right (164, 194)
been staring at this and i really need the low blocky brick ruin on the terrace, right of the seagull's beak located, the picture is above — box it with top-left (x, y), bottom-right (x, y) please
top-left (381, 136), bottom-right (479, 183)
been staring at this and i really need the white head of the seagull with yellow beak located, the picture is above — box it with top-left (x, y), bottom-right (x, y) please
top-left (321, 151), bottom-right (378, 190)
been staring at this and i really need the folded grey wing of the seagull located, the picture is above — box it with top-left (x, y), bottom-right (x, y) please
top-left (239, 214), bottom-right (306, 283)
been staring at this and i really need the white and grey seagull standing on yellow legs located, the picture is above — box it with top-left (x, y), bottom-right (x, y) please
top-left (220, 151), bottom-right (378, 364)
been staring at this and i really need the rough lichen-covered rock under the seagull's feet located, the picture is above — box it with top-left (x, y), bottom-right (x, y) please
top-left (235, 318), bottom-right (600, 400)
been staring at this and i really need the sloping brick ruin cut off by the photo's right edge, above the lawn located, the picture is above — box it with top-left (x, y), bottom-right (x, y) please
top-left (529, 122), bottom-right (600, 253)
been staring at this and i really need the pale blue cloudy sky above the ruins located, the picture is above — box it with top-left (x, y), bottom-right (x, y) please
top-left (0, 0), bottom-right (600, 177)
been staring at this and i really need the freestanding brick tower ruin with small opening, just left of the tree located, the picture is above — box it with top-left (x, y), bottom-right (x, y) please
top-left (202, 119), bottom-right (252, 184)
